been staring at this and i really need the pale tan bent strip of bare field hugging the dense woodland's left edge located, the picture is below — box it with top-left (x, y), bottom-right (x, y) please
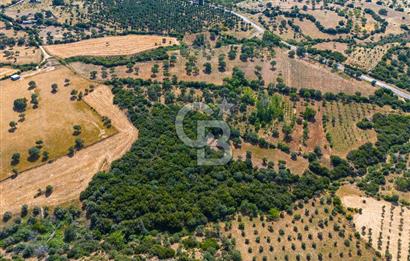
top-left (0, 85), bottom-right (138, 214)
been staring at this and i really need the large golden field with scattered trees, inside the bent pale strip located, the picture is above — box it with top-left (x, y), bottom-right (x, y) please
top-left (0, 67), bottom-right (117, 179)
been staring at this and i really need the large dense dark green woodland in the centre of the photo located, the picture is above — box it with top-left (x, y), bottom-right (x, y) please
top-left (81, 84), bottom-right (327, 239)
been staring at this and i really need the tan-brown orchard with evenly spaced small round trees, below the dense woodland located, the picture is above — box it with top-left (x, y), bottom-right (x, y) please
top-left (221, 197), bottom-right (379, 261)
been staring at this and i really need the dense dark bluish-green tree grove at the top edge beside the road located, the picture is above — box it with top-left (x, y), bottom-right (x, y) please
top-left (82, 0), bottom-right (239, 34)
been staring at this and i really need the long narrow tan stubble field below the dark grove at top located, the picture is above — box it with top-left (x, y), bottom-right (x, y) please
top-left (44, 35), bottom-right (178, 58)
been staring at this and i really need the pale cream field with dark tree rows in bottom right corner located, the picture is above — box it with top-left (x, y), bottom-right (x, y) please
top-left (342, 192), bottom-right (410, 261)
